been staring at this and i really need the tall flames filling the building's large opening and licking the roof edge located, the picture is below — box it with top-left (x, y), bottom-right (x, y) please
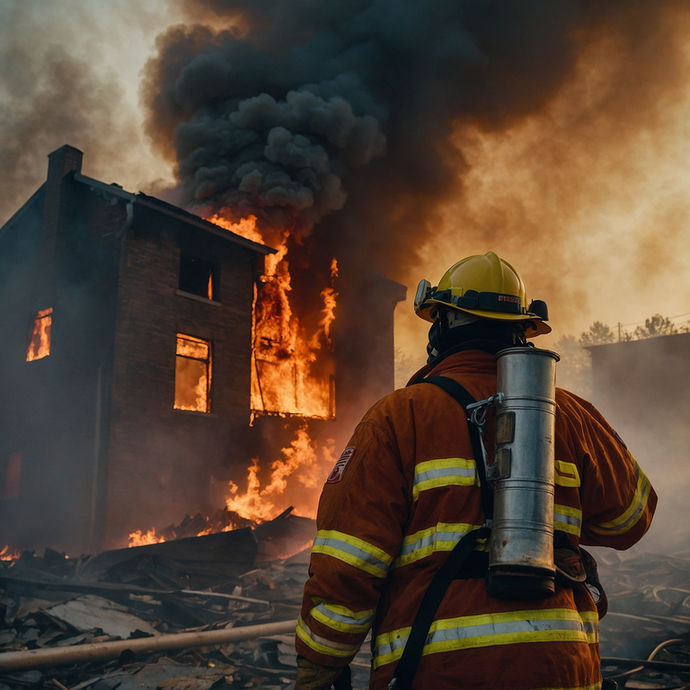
top-left (208, 212), bottom-right (338, 419)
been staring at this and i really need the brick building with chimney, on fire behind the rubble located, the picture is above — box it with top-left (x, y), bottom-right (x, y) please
top-left (0, 146), bottom-right (404, 550)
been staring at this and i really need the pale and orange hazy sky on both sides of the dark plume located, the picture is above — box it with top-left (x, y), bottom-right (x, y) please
top-left (0, 0), bottom-right (690, 376)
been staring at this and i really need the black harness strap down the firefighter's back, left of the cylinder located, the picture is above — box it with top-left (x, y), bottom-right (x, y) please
top-left (388, 376), bottom-right (493, 690)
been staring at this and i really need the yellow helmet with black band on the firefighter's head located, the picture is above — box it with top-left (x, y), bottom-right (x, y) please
top-left (414, 252), bottom-right (551, 337)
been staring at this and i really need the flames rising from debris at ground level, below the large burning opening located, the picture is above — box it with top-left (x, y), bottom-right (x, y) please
top-left (226, 424), bottom-right (334, 523)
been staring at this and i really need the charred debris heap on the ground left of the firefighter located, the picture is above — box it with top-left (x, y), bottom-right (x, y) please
top-left (0, 511), bottom-right (369, 690)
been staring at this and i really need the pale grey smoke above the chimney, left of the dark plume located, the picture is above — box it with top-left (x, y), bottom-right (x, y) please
top-left (0, 0), bottom-right (176, 224)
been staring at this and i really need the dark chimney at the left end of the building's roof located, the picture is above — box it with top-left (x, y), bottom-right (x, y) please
top-left (36, 145), bottom-right (84, 300)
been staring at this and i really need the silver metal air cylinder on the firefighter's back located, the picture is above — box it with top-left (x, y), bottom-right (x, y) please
top-left (487, 347), bottom-right (559, 599)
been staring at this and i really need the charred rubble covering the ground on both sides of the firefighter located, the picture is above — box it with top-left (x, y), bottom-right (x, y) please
top-left (9, 511), bottom-right (690, 690)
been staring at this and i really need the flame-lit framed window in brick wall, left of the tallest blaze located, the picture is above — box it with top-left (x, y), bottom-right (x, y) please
top-left (174, 333), bottom-right (212, 413)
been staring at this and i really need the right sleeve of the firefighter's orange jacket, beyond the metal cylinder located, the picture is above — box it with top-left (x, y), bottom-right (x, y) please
top-left (573, 396), bottom-right (657, 550)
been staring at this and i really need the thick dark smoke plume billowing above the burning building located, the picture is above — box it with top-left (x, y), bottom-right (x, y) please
top-left (144, 0), bottom-right (682, 278)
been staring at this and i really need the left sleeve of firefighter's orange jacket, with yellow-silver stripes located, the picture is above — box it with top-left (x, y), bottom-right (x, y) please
top-left (296, 399), bottom-right (409, 666)
